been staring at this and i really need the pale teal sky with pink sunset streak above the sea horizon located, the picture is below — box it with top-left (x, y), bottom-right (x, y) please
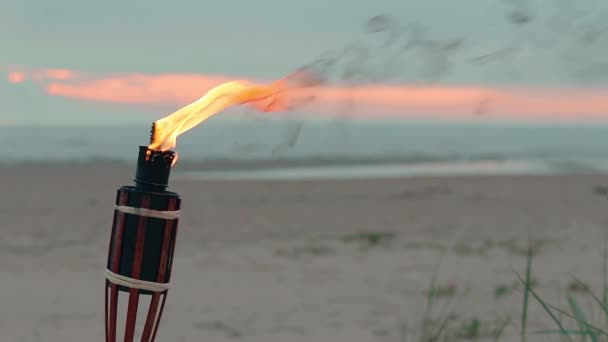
top-left (0, 0), bottom-right (608, 124)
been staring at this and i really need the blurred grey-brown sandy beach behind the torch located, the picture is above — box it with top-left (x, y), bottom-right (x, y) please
top-left (0, 164), bottom-right (608, 342)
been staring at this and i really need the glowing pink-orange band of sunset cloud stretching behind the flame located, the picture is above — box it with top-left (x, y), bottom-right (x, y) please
top-left (8, 69), bottom-right (608, 121)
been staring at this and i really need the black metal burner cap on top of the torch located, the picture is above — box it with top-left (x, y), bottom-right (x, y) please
top-left (133, 146), bottom-right (175, 192)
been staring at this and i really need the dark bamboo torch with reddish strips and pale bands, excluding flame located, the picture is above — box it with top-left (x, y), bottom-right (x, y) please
top-left (105, 146), bottom-right (181, 342)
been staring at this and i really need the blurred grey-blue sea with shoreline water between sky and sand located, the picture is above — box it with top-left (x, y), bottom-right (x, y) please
top-left (0, 120), bottom-right (608, 179)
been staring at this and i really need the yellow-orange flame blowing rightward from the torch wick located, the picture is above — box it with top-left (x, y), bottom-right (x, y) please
top-left (149, 74), bottom-right (310, 151)
